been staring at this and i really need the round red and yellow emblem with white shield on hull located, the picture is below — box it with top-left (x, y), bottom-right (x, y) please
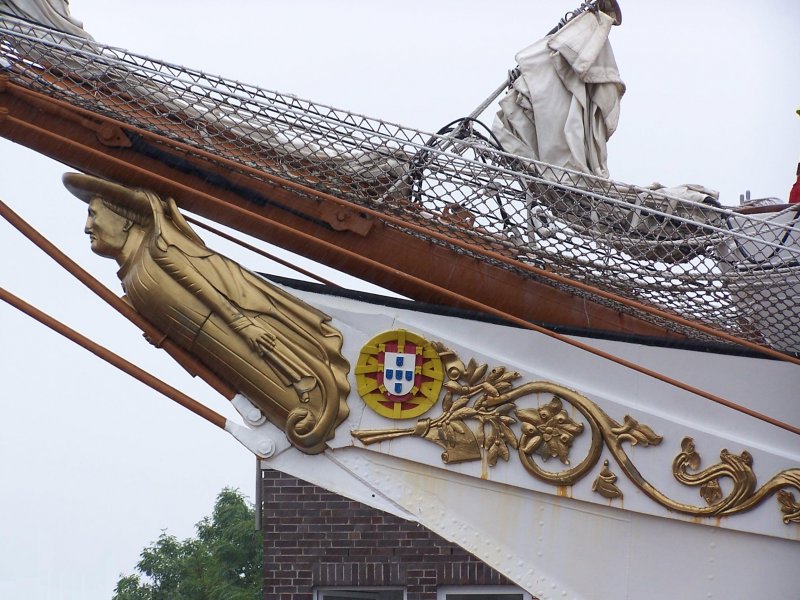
top-left (355, 329), bottom-right (444, 419)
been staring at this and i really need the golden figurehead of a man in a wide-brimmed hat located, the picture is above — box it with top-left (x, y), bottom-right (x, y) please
top-left (63, 173), bottom-right (350, 453)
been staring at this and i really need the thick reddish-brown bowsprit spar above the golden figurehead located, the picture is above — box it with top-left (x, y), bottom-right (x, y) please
top-left (0, 81), bottom-right (682, 338)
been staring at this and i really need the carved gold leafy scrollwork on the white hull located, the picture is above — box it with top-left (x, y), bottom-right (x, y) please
top-left (351, 344), bottom-right (800, 523)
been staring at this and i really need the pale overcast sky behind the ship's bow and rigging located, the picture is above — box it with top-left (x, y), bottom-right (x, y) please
top-left (0, 0), bottom-right (800, 600)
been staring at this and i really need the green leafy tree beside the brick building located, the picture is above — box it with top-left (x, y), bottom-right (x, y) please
top-left (113, 488), bottom-right (264, 600)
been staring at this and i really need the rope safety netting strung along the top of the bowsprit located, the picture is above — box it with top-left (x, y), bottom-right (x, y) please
top-left (0, 16), bottom-right (800, 353)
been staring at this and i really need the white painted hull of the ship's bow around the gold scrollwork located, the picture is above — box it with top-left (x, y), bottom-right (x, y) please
top-left (252, 290), bottom-right (800, 600)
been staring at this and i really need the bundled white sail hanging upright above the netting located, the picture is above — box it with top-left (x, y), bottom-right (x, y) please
top-left (493, 12), bottom-right (625, 177)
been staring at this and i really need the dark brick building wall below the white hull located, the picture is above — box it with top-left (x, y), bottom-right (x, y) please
top-left (261, 470), bottom-right (511, 600)
